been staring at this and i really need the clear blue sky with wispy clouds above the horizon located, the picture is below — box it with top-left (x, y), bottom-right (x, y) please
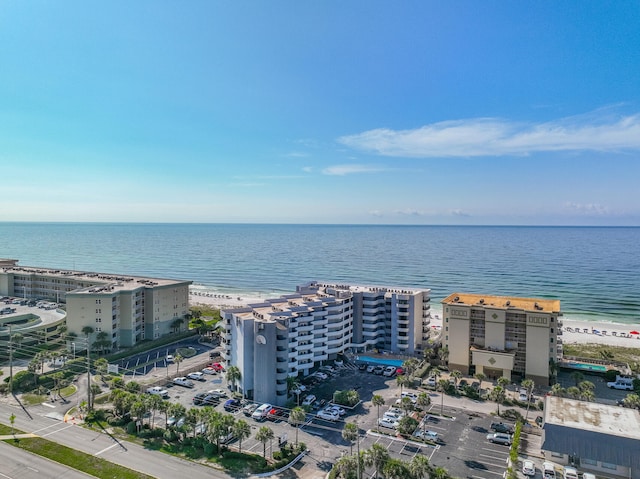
top-left (0, 0), bottom-right (640, 225)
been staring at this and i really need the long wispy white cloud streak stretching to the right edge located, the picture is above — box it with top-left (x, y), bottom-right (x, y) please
top-left (338, 111), bottom-right (640, 158)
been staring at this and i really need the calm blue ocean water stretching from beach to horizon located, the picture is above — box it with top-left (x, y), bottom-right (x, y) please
top-left (0, 223), bottom-right (640, 324)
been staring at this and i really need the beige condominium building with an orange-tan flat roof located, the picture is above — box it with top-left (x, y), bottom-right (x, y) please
top-left (442, 293), bottom-right (562, 385)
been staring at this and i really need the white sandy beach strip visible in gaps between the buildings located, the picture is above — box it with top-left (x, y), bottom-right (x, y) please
top-left (190, 291), bottom-right (640, 348)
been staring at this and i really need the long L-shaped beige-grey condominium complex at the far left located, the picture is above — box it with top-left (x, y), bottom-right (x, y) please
top-left (0, 260), bottom-right (191, 349)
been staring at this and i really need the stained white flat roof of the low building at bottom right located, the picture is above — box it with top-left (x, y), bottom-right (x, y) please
top-left (544, 396), bottom-right (640, 439)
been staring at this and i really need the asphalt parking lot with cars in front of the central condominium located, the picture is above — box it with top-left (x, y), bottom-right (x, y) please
top-left (131, 349), bottom-right (520, 479)
